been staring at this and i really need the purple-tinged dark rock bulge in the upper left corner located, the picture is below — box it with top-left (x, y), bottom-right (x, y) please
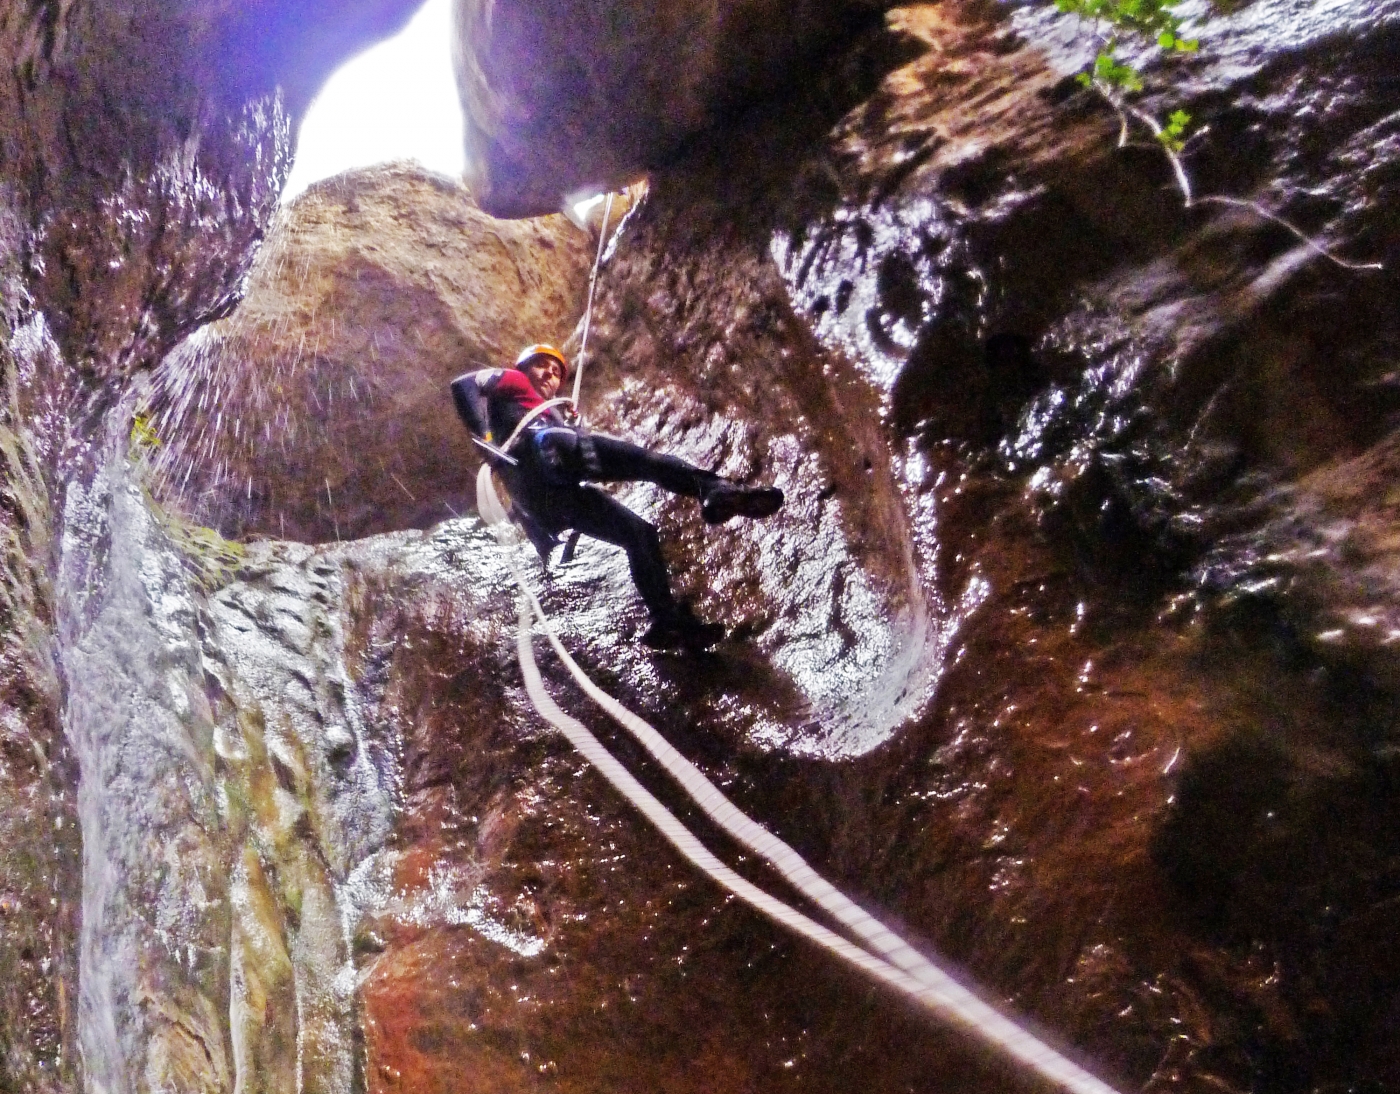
top-left (0, 0), bottom-right (412, 378)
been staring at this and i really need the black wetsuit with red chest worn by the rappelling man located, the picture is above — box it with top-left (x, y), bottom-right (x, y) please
top-left (452, 368), bottom-right (725, 622)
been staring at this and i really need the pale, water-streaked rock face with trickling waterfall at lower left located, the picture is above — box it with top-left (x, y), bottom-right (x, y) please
top-left (56, 434), bottom-right (398, 1091)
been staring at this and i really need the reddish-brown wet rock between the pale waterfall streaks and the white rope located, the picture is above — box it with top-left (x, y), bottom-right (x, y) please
top-left (352, 588), bottom-right (1058, 1094)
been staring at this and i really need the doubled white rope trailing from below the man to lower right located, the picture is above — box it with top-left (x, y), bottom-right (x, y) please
top-left (476, 465), bottom-right (1114, 1094)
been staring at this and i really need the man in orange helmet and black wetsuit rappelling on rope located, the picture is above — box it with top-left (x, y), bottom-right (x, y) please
top-left (452, 345), bottom-right (783, 649)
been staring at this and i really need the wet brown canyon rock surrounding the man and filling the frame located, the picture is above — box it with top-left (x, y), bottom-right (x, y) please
top-left (0, 0), bottom-right (1400, 1094)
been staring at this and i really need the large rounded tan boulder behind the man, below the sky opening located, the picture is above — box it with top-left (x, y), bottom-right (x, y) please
top-left (133, 167), bottom-right (592, 542)
